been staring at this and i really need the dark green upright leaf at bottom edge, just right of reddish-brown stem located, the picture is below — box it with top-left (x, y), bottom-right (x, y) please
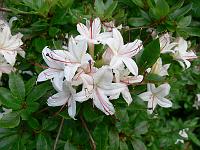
top-left (93, 124), bottom-right (108, 149)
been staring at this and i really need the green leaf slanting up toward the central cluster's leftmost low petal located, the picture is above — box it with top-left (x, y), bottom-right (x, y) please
top-left (26, 83), bottom-right (51, 102)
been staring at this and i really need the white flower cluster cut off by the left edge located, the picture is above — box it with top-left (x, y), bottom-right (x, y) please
top-left (0, 20), bottom-right (25, 77)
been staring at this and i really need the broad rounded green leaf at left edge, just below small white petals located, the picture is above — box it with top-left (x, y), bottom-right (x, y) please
top-left (0, 112), bottom-right (20, 128)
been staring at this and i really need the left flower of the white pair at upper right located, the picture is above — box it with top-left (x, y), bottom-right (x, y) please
top-left (159, 33), bottom-right (177, 54)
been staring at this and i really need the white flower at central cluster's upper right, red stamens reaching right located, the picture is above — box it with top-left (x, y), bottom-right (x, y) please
top-left (104, 28), bottom-right (143, 75)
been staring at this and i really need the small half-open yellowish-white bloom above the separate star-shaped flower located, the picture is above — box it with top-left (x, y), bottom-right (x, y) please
top-left (147, 58), bottom-right (170, 76)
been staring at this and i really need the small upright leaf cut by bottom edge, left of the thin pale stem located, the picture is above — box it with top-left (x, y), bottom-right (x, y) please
top-left (36, 134), bottom-right (48, 150)
